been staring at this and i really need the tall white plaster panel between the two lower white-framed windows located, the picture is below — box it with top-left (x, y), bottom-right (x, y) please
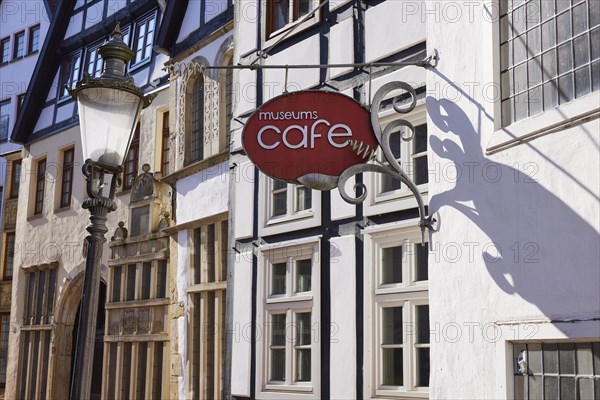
top-left (329, 236), bottom-right (356, 399)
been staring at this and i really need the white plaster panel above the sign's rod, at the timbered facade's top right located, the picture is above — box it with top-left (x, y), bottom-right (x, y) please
top-left (365, 0), bottom-right (424, 62)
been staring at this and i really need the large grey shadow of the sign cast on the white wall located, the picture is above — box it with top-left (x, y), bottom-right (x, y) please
top-left (427, 97), bottom-right (600, 319)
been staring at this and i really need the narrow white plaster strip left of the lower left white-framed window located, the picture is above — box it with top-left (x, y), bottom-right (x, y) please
top-left (231, 247), bottom-right (252, 396)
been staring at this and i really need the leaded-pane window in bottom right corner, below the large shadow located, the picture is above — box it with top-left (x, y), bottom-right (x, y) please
top-left (513, 342), bottom-right (600, 400)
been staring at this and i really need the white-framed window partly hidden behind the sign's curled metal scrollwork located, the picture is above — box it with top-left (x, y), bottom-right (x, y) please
top-left (375, 105), bottom-right (429, 200)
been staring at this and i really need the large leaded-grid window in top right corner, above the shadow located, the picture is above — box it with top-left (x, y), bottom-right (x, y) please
top-left (500, 0), bottom-right (600, 126)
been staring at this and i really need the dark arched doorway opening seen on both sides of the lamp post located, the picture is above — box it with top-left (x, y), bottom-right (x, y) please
top-left (69, 282), bottom-right (106, 400)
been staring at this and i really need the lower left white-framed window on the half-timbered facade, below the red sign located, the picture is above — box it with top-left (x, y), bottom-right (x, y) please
top-left (261, 242), bottom-right (319, 394)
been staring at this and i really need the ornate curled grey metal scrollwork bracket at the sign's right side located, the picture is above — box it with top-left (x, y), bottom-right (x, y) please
top-left (338, 82), bottom-right (433, 242)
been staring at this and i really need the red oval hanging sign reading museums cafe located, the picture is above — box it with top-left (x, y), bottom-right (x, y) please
top-left (242, 91), bottom-right (377, 190)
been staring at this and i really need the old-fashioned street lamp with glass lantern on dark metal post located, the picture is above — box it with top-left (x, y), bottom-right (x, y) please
top-left (67, 22), bottom-right (152, 400)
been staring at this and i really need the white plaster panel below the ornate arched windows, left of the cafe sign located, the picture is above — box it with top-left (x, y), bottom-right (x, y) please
top-left (176, 161), bottom-right (229, 224)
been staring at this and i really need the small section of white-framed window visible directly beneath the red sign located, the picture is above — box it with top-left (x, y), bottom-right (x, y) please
top-left (270, 179), bottom-right (312, 218)
